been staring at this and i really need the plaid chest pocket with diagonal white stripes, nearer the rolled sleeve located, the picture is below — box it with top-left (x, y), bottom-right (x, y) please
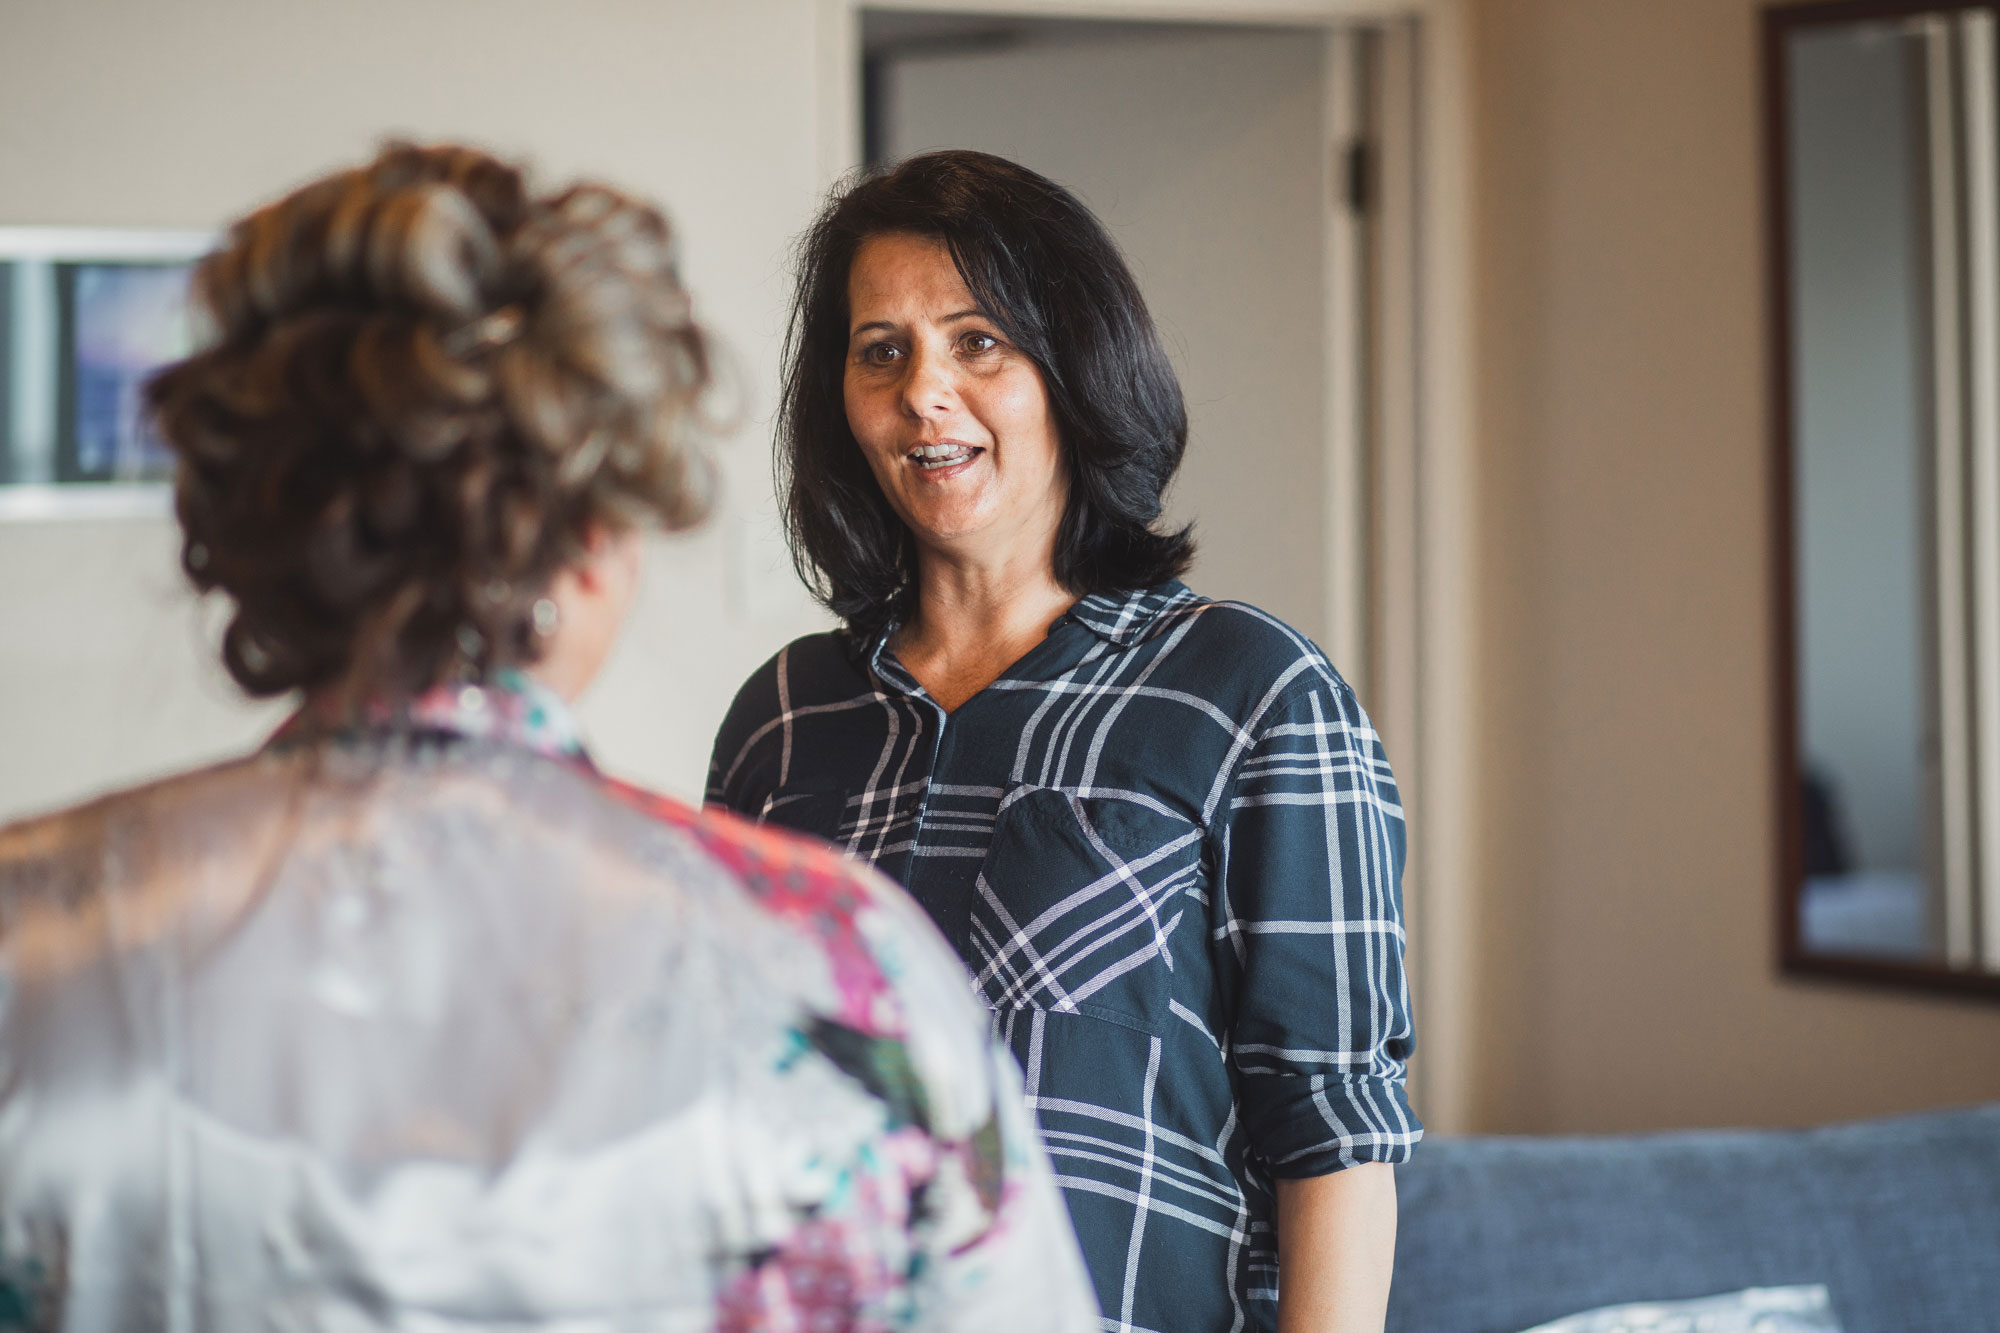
top-left (966, 787), bottom-right (1204, 1033)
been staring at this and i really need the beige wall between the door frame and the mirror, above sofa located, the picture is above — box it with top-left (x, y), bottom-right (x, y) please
top-left (1476, 0), bottom-right (2000, 1131)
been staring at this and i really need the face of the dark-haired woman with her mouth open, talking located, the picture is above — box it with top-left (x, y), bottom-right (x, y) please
top-left (844, 232), bottom-right (1068, 562)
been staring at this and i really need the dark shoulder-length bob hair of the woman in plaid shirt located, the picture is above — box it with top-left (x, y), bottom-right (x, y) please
top-left (778, 150), bottom-right (1194, 634)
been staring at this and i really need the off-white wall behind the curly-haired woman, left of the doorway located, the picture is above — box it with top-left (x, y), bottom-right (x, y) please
top-left (0, 0), bottom-right (820, 819)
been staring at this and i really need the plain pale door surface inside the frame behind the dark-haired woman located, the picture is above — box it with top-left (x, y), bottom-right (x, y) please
top-left (882, 28), bottom-right (1358, 644)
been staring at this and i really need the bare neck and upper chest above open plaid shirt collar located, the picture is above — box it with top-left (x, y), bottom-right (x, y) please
top-left (894, 552), bottom-right (1076, 713)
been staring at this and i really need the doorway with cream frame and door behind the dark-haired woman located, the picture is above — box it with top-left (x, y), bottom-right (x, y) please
top-left (820, 0), bottom-right (1476, 1133)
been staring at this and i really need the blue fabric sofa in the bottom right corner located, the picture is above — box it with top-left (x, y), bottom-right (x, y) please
top-left (1388, 1105), bottom-right (2000, 1333)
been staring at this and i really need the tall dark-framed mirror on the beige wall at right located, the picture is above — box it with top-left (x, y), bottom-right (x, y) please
top-left (1766, 6), bottom-right (2000, 981)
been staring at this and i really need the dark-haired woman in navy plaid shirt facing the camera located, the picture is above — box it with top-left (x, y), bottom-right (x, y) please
top-left (708, 152), bottom-right (1422, 1333)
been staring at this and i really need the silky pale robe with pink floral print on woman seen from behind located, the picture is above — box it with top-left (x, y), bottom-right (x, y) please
top-left (0, 677), bottom-right (1098, 1331)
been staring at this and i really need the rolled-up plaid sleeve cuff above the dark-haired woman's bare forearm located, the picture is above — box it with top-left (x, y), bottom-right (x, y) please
top-left (1242, 1075), bottom-right (1424, 1181)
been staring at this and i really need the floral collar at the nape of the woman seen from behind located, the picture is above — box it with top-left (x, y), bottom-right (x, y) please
top-left (270, 667), bottom-right (590, 763)
